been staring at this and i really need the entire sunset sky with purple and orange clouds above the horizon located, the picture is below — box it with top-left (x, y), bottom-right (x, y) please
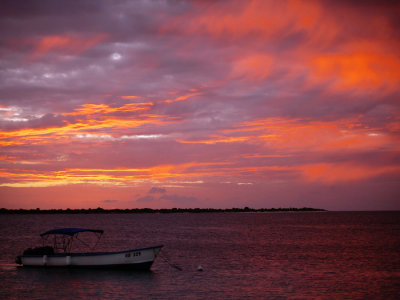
top-left (0, 0), bottom-right (400, 210)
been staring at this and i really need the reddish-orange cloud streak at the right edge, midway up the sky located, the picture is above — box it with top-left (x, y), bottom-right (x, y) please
top-left (225, 118), bottom-right (400, 154)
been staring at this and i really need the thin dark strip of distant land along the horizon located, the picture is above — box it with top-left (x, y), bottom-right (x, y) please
top-left (0, 207), bottom-right (326, 215)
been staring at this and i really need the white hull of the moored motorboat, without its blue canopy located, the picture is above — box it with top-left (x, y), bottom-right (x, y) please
top-left (15, 246), bottom-right (162, 270)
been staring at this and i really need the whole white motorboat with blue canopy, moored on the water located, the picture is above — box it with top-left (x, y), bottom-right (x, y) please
top-left (16, 228), bottom-right (163, 270)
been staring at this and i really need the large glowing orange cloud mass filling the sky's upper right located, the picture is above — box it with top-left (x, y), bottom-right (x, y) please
top-left (161, 0), bottom-right (400, 92)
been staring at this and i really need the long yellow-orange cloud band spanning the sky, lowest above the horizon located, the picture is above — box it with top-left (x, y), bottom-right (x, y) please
top-left (0, 152), bottom-right (400, 187)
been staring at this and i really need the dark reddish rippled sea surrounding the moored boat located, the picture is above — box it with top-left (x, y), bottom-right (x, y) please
top-left (0, 212), bottom-right (400, 299)
